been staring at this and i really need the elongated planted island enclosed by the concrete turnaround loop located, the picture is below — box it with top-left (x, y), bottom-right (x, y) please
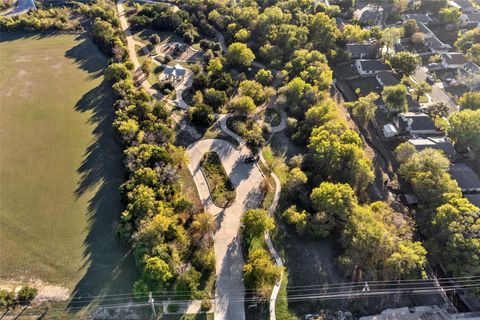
top-left (201, 152), bottom-right (236, 208)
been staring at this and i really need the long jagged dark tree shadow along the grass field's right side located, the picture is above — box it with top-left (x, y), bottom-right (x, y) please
top-left (67, 37), bottom-right (137, 312)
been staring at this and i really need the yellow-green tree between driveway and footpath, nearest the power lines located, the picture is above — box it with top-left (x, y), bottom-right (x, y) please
top-left (243, 248), bottom-right (282, 297)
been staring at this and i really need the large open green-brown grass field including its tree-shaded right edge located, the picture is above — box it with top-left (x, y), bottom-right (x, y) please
top-left (0, 34), bottom-right (136, 296)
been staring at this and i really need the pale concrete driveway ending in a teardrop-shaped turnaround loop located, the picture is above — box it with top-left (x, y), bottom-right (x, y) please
top-left (187, 139), bottom-right (263, 320)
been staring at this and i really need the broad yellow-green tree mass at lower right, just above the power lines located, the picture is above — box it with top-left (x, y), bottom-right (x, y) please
top-left (340, 202), bottom-right (426, 281)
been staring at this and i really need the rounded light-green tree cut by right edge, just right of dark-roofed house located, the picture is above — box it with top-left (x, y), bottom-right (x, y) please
top-left (448, 109), bottom-right (480, 156)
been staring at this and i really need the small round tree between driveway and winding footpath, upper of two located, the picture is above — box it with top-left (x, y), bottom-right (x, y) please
top-left (242, 209), bottom-right (275, 246)
